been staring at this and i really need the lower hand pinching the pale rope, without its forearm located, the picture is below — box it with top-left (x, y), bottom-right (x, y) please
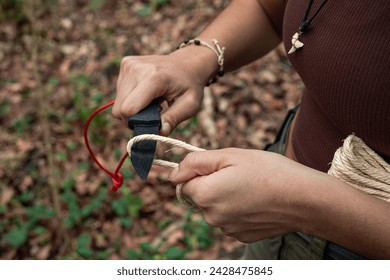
top-left (170, 148), bottom-right (321, 242)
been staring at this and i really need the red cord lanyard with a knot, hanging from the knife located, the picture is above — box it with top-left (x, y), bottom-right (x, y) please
top-left (84, 100), bottom-right (128, 191)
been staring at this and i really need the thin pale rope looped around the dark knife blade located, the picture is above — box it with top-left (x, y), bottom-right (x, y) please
top-left (127, 134), bottom-right (206, 208)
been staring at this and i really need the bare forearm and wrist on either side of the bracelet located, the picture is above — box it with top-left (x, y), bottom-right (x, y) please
top-left (174, 0), bottom-right (284, 85)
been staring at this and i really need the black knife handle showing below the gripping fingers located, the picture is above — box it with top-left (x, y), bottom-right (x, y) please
top-left (127, 98), bottom-right (161, 130)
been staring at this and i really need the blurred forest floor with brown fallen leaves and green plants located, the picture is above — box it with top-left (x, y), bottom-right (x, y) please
top-left (0, 0), bottom-right (302, 259)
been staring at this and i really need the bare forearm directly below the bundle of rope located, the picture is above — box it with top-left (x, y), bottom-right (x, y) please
top-left (302, 174), bottom-right (390, 259)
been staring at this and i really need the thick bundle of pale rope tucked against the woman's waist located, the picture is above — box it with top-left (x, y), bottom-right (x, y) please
top-left (328, 135), bottom-right (390, 202)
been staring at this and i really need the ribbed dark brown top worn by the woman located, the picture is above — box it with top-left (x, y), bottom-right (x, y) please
top-left (283, 0), bottom-right (390, 172)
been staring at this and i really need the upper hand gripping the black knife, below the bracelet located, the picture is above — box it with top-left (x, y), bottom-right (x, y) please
top-left (112, 46), bottom-right (217, 136)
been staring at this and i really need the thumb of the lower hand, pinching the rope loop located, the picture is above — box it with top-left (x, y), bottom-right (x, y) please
top-left (169, 150), bottom-right (231, 184)
